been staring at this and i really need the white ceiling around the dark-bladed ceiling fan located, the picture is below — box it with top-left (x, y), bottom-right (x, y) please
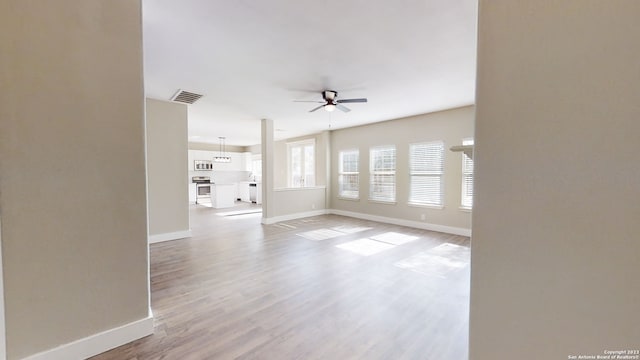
top-left (143, 0), bottom-right (477, 146)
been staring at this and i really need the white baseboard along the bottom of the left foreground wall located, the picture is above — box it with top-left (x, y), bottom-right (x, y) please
top-left (23, 312), bottom-right (153, 360)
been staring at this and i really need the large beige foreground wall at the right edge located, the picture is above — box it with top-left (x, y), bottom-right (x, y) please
top-left (470, 0), bottom-right (640, 360)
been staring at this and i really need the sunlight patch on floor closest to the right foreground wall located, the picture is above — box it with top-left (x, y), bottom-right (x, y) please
top-left (394, 243), bottom-right (471, 278)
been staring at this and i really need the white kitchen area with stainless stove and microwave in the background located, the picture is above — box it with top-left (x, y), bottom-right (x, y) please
top-left (188, 149), bottom-right (262, 209)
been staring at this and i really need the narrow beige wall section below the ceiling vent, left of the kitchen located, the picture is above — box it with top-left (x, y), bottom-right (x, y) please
top-left (146, 99), bottom-right (189, 235)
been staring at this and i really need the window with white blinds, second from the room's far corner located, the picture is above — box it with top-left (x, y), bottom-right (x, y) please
top-left (369, 146), bottom-right (396, 202)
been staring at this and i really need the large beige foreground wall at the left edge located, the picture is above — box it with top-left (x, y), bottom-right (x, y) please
top-left (0, 0), bottom-right (149, 359)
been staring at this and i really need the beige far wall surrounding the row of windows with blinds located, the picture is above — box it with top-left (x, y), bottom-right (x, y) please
top-left (330, 106), bottom-right (474, 229)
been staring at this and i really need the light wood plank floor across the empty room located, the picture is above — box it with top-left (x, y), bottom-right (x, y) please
top-left (93, 205), bottom-right (469, 360)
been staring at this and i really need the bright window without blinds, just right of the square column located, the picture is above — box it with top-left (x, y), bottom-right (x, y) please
top-left (287, 139), bottom-right (316, 187)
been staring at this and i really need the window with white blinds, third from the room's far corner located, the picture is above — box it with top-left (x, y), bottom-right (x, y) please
top-left (409, 141), bottom-right (444, 206)
